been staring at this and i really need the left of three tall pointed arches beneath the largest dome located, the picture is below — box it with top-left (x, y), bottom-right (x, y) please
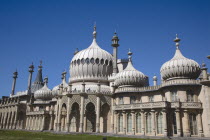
top-left (70, 103), bottom-right (80, 132)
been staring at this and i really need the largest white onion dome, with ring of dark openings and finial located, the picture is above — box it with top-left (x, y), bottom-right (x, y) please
top-left (70, 26), bottom-right (113, 83)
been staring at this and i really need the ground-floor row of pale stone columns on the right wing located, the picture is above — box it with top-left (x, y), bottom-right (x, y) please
top-left (113, 109), bottom-right (203, 137)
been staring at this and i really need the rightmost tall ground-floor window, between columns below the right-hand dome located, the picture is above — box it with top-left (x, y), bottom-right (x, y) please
top-left (189, 113), bottom-right (198, 135)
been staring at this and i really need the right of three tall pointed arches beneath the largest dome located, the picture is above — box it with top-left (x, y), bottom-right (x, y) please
top-left (101, 103), bottom-right (110, 133)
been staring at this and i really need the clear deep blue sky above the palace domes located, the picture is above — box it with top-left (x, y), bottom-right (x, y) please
top-left (0, 0), bottom-right (210, 97)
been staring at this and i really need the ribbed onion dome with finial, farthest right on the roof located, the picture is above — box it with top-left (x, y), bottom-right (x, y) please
top-left (160, 35), bottom-right (201, 80)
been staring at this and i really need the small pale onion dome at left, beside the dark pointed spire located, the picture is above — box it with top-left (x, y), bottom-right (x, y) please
top-left (34, 78), bottom-right (52, 100)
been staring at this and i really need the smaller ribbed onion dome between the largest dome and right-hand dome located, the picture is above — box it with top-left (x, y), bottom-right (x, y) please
top-left (115, 50), bottom-right (148, 87)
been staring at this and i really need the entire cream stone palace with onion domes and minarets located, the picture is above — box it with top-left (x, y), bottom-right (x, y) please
top-left (0, 26), bottom-right (210, 137)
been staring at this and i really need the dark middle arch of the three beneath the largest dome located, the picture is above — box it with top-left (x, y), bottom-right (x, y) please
top-left (85, 103), bottom-right (96, 132)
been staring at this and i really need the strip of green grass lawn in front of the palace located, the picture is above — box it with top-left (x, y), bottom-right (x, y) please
top-left (0, 130), bottom-right (164, 140)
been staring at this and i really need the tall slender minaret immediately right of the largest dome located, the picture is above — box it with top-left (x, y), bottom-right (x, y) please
top-left (112, 32), bottom-right (119, 74)
